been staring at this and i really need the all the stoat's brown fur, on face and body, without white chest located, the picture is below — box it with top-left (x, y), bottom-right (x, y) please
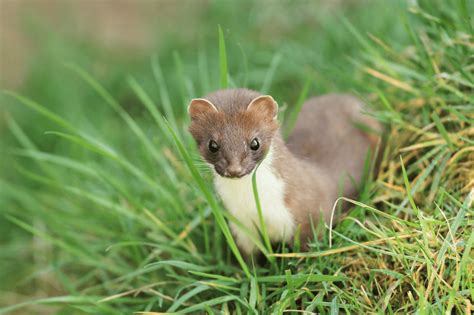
top-left (190, 89), bottom-right (380, 247)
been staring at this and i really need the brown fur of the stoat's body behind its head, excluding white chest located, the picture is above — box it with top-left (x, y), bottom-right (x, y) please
top-left (277, 94), bottom-right (381, 240)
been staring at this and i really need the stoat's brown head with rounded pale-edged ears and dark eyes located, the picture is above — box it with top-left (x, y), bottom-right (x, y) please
top-left (188, 89), bottom-right (278, 178)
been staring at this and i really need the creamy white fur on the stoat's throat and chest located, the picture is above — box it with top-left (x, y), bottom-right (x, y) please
top-left (215, 149), bottom-right (295, 253)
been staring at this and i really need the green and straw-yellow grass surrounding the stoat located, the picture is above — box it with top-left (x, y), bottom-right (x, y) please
top-left (0, 0), bottom-right (474, 314)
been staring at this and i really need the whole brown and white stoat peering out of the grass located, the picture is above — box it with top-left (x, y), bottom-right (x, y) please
top-left (188, 89), bottom-right (380, 254)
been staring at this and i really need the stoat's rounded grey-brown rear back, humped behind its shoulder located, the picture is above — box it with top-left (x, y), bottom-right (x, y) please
top-left (287, 94), bottom-right (381, 200)
